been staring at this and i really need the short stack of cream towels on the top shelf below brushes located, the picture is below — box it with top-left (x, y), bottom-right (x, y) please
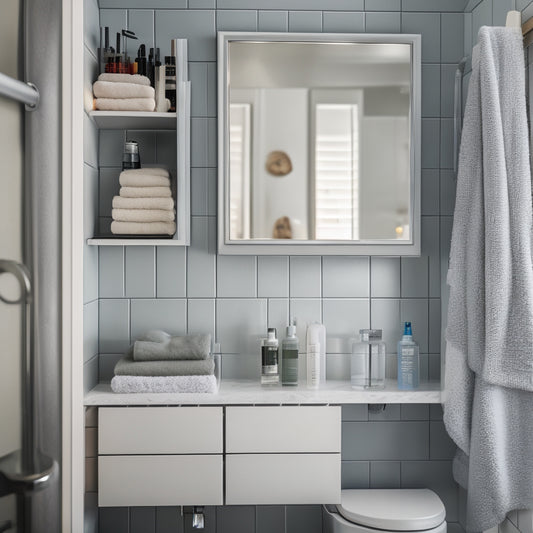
top-left (93, 73), bottom-right (159, 111)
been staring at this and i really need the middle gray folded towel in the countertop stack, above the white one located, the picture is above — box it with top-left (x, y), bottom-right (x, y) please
top-left (115, 354), bottom-right (215, 376)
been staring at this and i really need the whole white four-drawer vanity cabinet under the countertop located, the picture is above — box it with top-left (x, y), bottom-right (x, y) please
top-left (98, 405), bottom-right (341, 507)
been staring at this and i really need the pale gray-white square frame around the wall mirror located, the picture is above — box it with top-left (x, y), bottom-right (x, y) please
top-left (217, 32), bottom-right (422, 256)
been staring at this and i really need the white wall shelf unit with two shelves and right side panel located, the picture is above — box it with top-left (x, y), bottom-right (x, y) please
top-left (87, 81), bottom-right (191, 246)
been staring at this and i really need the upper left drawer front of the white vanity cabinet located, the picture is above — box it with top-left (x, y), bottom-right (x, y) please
top-left (98, 407), bottom-right (223, 454)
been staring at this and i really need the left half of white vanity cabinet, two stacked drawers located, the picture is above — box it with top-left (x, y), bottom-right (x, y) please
top-left (98, 407), bottom-right (223, 507)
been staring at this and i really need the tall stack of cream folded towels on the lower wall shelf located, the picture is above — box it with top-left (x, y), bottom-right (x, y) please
top-left (111, 167), bottom-right (176, 235)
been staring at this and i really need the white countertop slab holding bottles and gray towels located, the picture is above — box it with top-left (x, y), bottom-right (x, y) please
top-left (84, 379), bottom-right (441, 406)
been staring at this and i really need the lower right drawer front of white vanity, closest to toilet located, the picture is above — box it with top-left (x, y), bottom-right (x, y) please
top-left (226, 453), bottom-right (341, 505)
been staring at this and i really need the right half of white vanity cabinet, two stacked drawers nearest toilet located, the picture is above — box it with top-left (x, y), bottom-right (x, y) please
top-left (226, 406), bottom-right (341, 505)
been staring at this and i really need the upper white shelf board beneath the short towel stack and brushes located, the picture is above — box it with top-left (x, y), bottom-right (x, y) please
top-left (89, 111), bottom-right (176, 130)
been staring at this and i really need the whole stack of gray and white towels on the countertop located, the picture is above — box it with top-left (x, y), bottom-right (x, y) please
top-left (111, 330), bottom-right (217, 393)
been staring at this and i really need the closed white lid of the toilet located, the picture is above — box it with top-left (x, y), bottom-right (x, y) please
top-left (337, 489), bottom-right (446, 531)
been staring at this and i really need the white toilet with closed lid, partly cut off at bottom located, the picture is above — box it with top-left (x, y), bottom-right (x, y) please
top-left (323, 489), bottom-right (446, 533)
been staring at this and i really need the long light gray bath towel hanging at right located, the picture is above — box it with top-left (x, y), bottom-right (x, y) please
top-left (444, 27), bottom-right (533, 531)
